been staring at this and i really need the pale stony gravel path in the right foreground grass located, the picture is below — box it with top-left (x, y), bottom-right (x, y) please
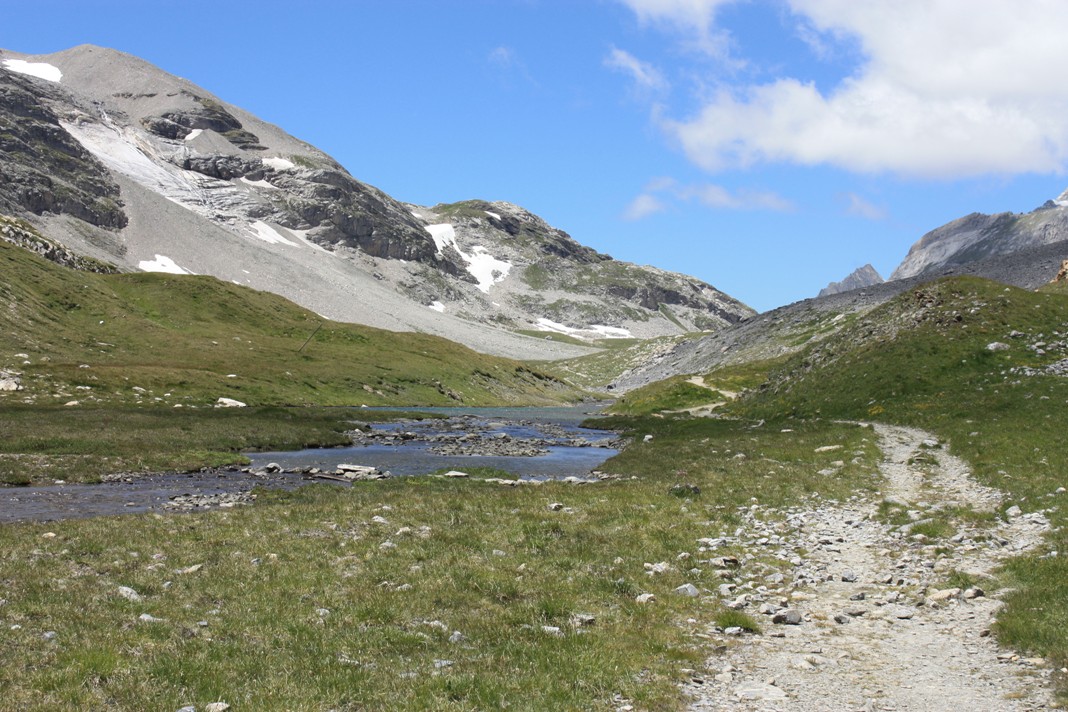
top-left (687, 425), bottom-right (1059, 712)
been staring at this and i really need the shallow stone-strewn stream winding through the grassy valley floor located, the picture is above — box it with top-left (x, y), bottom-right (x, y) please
top-left (0, 409), bottom-right (621, 523)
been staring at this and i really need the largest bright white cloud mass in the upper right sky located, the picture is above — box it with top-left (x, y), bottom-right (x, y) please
top-left (621, 0), bottom-right (1068, 178)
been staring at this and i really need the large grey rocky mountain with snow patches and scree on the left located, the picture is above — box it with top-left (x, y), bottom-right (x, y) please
top-left (0, 45), bottom-right (754, 359)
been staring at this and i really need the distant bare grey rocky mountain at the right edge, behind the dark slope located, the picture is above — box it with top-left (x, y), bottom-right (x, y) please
top-left (890, 191), bottom-right (1068, 281)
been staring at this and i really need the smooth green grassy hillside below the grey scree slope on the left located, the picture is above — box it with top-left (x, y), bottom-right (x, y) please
top-left (0, 233), bottom-right (578, 407)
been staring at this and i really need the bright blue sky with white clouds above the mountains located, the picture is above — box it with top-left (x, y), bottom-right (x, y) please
top-left (6, 0), bottom-right (1068, 311)
